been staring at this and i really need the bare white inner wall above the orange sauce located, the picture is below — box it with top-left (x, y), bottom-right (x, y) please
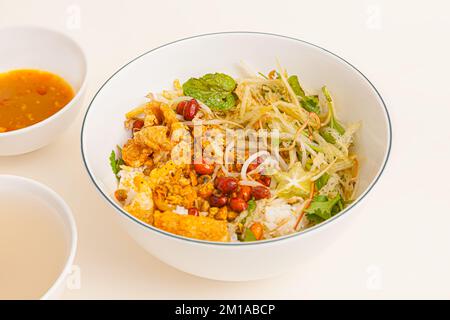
top-left (0, 27), bottom-right (86, 93)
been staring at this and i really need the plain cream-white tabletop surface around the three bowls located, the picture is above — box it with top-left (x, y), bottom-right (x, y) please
top-left (0, 0), bottom-right (450, 299)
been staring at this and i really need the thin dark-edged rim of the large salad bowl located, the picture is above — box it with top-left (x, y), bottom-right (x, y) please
top-left (80, 31), bottom-right (392, 247)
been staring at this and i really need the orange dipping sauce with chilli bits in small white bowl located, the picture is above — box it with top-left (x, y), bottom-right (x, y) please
top-left (0, 69), bottom-right (75, 134)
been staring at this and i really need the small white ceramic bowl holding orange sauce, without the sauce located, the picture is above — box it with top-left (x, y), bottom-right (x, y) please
top-left (0, 27), bottom-right (87, 156)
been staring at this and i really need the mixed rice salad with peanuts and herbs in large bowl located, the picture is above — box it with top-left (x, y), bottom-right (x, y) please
top-left (109, 63), bottom-right (360, 242)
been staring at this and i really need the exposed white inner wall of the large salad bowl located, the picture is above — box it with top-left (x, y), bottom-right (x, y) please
top-left (82, 33), bottom-right (390, 240)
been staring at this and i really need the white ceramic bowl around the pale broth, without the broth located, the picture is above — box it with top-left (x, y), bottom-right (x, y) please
top-left (0, 175), bottom-right (78, 300)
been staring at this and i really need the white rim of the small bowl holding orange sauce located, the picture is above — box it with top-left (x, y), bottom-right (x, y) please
top-left (0, 25), bottom-right (89, 139)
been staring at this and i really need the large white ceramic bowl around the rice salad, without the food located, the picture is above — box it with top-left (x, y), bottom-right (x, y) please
top-left (81, 32), bottom-right (391, 281)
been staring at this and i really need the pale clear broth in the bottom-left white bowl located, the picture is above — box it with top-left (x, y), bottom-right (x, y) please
top-left (0, 192), bottom-right (68, 299)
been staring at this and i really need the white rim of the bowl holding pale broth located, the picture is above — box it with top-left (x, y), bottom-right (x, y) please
top-left (0, 174), bottom-right (78, 300)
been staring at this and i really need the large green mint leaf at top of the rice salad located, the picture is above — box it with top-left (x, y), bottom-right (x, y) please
top-left (183, 73), bottom-right (236, 111)
